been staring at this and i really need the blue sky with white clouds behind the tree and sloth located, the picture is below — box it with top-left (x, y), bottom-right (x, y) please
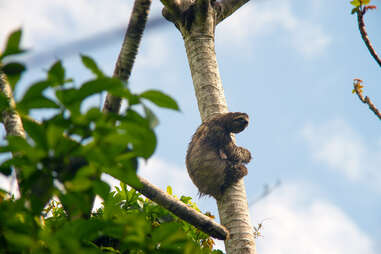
top-left (0, 0), bottom-right (381, 254)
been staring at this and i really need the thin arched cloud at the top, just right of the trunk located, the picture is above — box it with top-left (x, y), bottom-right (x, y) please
top-left (217, 0), bottom-right (331, 58)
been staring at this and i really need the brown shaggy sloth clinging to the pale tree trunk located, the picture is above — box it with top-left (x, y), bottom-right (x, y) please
top-left (186, 112), bottom-right (251, 199)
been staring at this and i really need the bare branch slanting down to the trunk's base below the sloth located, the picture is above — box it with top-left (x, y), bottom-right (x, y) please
top-left (131, 177), bottom-right (229, 240)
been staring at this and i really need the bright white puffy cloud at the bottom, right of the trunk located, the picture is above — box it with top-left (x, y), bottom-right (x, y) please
top-left (252, 184), bottom-right (376, 254)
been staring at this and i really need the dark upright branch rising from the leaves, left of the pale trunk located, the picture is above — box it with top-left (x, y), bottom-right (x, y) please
top-left (103, 0), bottom-right (152, 113)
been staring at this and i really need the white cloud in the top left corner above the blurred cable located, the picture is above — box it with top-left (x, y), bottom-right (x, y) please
top-left (0, 0), bottom-right (132, 49)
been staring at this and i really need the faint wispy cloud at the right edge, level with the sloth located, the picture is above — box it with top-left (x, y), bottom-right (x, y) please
top-left (302, 120), bottom-right (381, 186)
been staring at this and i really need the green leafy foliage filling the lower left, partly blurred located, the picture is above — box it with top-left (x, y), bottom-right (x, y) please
top-left (0, 30), bottom-right (219, 253)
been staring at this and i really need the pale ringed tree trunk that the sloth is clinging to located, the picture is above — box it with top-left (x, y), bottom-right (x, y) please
top-left (161, 0), bottom-right (256, 254)
